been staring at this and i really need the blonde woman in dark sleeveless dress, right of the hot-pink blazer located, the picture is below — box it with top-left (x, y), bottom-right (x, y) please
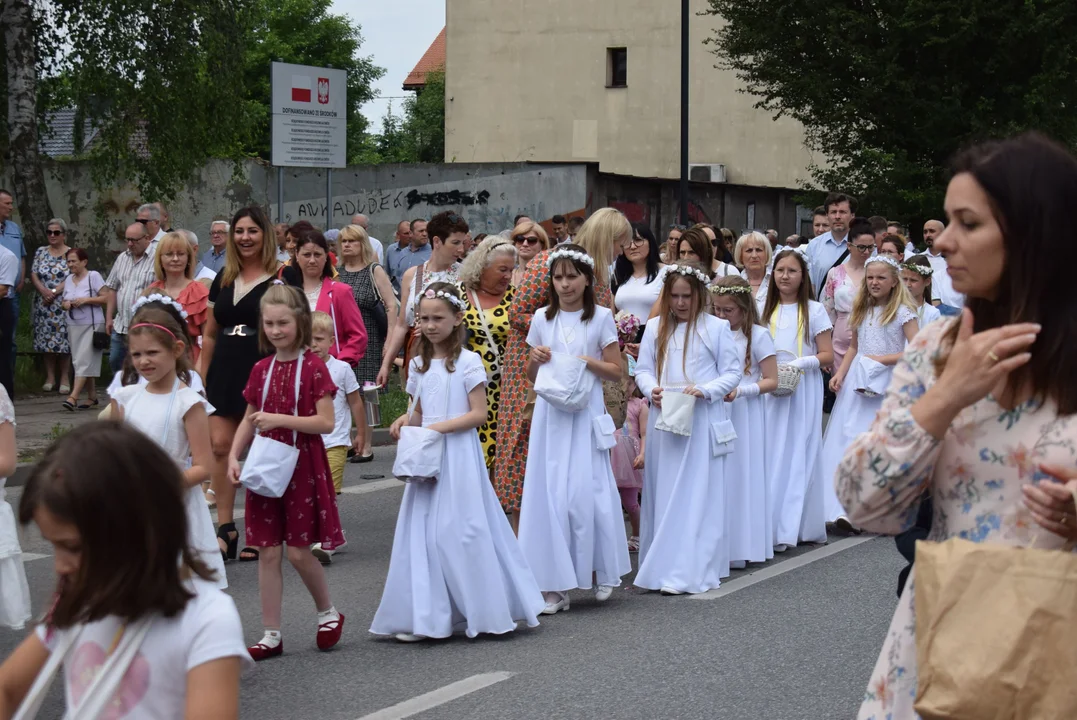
top-left (337, 225), bottom-right (396, 463)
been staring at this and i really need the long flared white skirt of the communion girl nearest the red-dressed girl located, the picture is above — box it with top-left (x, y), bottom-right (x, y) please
top-left (370, 430), bottom-right (546, 637)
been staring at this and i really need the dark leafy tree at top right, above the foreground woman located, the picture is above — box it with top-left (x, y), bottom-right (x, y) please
top-left (708, 0), bottom-right (1077, 220)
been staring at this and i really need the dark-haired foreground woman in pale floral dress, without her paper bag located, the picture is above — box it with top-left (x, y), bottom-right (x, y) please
top-left (835, 135), bottom-right (1077, 720)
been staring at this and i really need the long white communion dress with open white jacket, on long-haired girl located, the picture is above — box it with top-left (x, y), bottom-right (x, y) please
top-left (635, 314), bottom-right (743, 593)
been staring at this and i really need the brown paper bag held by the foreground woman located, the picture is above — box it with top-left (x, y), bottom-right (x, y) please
top-left (914, 538), bottom-right (1077, 720)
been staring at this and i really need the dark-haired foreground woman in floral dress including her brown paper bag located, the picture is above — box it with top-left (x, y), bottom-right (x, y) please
top-left (834, 133), bottom-right (1077, 719)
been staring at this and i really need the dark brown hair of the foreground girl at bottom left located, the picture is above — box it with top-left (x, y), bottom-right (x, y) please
top-left (18, 421), bottom-right (214, 629)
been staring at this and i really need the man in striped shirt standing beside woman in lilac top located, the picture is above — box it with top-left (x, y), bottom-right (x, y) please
top-left (104, 223), bottom-right (157, 372)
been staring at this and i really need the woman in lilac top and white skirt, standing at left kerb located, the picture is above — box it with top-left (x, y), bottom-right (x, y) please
top-left (56, 248), bottom-right (109, 410)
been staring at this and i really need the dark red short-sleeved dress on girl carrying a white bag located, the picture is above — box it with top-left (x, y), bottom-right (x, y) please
top-left (243, 352), bottom-right (345, 550)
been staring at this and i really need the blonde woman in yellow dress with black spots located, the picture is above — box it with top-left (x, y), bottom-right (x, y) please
top-left (460, 235), bottom-right (517, 470)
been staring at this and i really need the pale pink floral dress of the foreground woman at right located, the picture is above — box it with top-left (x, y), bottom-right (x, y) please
top-left (835, 321), bottom-right (1077, 720)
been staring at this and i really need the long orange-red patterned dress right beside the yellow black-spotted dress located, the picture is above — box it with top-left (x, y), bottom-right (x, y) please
top-left (493, 250), bottom-right (613, 512)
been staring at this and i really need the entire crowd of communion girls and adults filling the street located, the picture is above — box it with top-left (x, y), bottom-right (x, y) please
top-left (0, 136), bottom-right (1077, 718)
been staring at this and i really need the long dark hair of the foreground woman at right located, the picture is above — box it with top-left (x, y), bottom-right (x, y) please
top-left (935, 132), bottom-right (1077, 415)
